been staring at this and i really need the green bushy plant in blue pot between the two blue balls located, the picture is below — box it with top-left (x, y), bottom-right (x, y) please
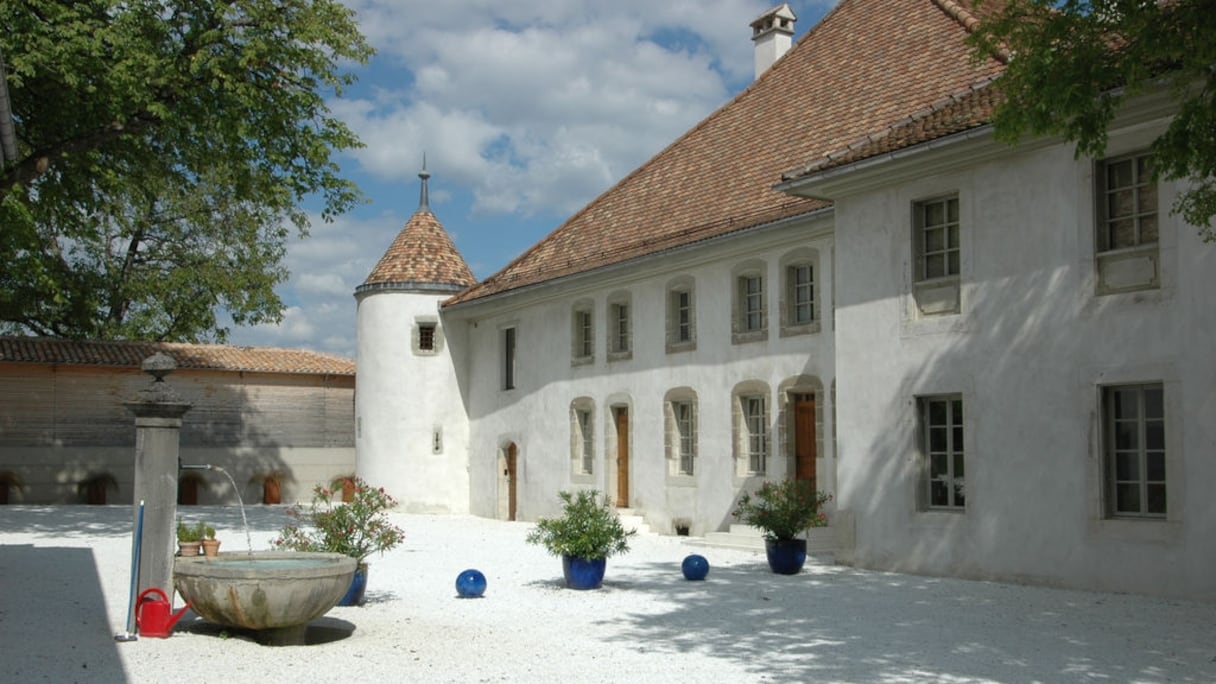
top-left (528, 489), bottom-right (637, 589)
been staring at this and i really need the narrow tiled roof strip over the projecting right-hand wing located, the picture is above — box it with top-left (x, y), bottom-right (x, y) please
top-left (782, 77), bottom-right (1001, 180)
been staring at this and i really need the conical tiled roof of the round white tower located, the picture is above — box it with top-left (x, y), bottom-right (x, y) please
top-left (355, 209), bottom-right (477, 292)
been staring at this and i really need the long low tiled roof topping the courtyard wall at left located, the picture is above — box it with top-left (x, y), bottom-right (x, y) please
top-left (0, 336), bottom-right (355, 375)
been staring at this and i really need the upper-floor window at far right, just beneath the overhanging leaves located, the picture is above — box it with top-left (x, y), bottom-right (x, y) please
top-left (1097, 155), bottom-right (1156, 252)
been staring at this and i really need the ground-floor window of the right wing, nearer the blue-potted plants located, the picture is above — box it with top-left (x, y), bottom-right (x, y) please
top-left (919, 394), bottom-right (967, 509)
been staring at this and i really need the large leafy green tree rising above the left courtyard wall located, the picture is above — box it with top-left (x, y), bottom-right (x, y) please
top-left (0, 0), bottom-right (372, 341)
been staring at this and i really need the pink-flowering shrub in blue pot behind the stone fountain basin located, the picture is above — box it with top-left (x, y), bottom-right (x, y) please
top-left (272, 477), bottom-right (405, 606)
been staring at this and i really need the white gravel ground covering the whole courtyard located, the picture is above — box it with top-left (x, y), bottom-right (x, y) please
top-left (0, 505), bottom-right (1216, 684)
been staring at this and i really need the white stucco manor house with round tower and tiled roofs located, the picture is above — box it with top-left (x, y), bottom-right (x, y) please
top-left (356, 0), bottom-right (1216, 599)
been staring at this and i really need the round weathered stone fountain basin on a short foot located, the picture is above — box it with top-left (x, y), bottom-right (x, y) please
top-left (173, 551), bottom-right (355, 643)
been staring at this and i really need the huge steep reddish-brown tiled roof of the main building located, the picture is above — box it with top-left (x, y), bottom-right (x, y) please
top-left (445, 0), bottom-right (1002, 305)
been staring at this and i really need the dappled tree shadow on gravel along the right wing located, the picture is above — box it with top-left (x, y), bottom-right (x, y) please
top-left (588, 557), bottom-right (1216, 683)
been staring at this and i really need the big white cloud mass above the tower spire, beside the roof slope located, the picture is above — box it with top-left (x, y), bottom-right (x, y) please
top-left (333, 0), bottom-right (770, 215)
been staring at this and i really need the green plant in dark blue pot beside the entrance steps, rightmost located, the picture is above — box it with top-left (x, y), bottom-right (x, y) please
top-left (733, 480), bottom-right (832, 574)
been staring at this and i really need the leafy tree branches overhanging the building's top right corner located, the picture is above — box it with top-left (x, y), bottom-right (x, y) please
top-left (972, 0), bottom-right (1216, 240)
